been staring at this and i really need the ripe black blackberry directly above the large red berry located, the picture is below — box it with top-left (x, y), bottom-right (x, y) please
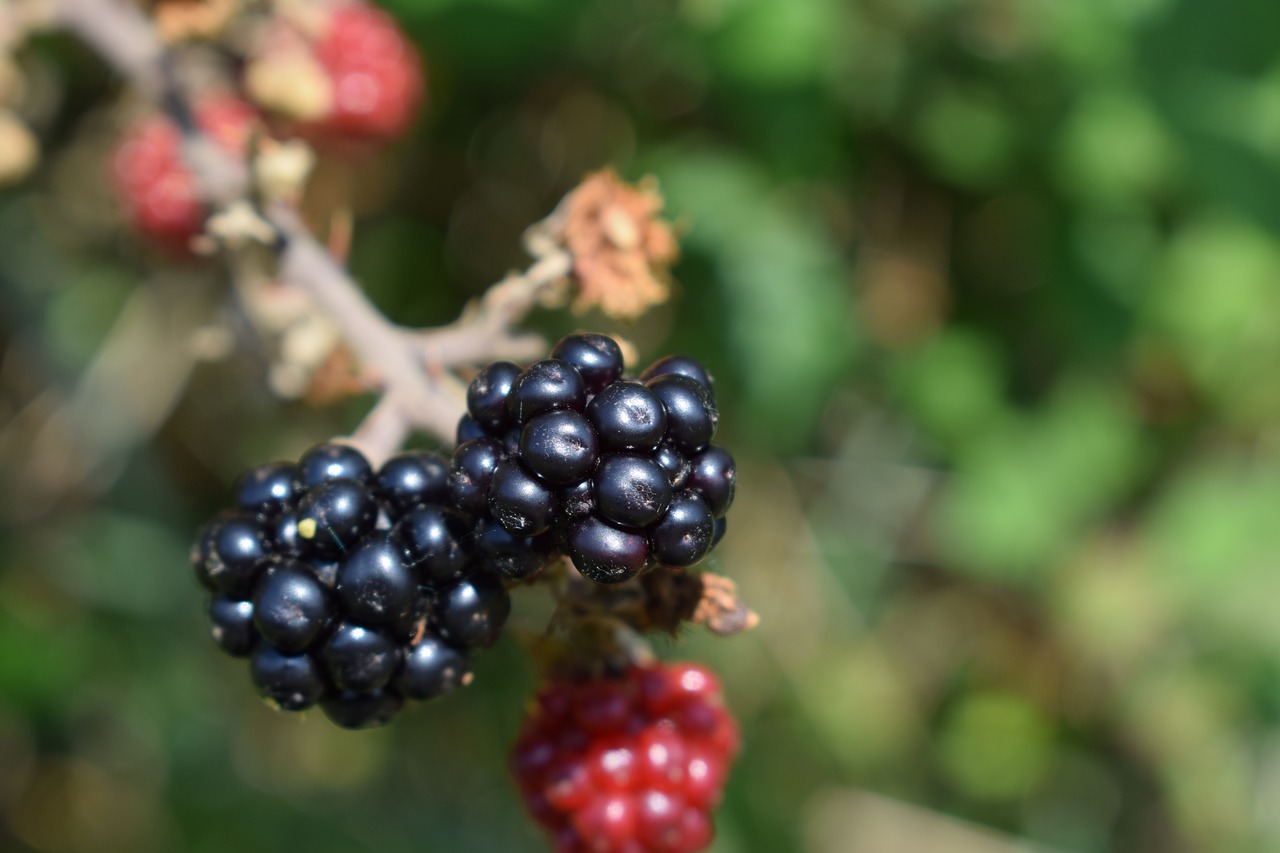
top-left (449, 334), bottom-right (736, 584)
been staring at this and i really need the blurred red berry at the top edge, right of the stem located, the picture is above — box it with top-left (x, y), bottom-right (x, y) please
top-left (303, 3), bottom-right (424, 142)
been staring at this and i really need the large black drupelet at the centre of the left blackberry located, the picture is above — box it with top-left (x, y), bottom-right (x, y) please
top-left (334, 530), bottom-right (417, 625)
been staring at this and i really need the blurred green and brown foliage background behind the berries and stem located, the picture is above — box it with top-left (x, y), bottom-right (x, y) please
top-left (0, 0), bottom-right (1280, 853)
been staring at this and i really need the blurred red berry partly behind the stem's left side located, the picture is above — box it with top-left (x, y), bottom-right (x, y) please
top-left (111, 96), bottom-right (255, 250)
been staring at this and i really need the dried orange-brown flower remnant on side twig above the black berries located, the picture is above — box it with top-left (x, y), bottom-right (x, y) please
top-left (562, 169), bottom-right (680, 320)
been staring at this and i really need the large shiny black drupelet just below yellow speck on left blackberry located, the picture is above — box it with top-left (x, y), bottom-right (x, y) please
top-left (253, 560), bottom-right (333, 654)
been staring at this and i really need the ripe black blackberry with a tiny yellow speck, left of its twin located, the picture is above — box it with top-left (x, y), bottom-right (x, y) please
top-left (192, 443), bottom-right (501, 729)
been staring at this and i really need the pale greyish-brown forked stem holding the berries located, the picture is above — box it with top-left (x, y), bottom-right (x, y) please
top-left (51, 0), bottom-right (572, 459)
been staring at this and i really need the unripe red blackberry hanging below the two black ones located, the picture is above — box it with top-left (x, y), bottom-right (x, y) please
top-left (511, 663), bottom-right (739, 853)
